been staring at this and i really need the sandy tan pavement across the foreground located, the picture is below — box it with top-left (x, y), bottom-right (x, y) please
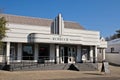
top-left (0, 66), bottom-right (120, 80)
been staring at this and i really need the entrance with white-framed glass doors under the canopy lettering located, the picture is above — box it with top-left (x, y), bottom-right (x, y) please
top-left (60, 46), bottom-right (76, 63)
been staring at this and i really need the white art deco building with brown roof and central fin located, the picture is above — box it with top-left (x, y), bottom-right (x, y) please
top-left (0, 14), bottom-right (107, 70)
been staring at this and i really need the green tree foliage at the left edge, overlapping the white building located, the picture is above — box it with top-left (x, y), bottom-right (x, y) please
top-left (0, 17), bottom-right (7, 48)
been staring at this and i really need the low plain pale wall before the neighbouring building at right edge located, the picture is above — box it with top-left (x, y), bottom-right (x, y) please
top-left (106, 53), bottom-right (120, 65)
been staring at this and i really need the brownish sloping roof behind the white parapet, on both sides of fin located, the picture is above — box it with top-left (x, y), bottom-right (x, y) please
top-left (0, 14), bottom-right (84, 29)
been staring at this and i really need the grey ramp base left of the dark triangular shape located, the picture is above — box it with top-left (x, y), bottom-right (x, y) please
top-left (10, 64), bottom-right (69, 71)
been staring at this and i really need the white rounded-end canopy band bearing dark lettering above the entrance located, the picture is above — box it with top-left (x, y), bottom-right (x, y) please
top-left (28, 33), bottom-right (100, 45)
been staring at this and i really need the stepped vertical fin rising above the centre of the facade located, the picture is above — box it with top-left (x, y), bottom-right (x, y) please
top-left (51, 14), bottom-right (64, 35)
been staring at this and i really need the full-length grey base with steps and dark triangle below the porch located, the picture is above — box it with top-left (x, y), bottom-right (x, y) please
top-left (2, 63), bottom-right (97, 71)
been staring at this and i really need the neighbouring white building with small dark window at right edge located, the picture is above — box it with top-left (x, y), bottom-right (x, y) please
top-left (106, 38), bottom-right (120, 65)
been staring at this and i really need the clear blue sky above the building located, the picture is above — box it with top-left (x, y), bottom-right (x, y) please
top-left (0, 0), bottom-right (120, 37)
